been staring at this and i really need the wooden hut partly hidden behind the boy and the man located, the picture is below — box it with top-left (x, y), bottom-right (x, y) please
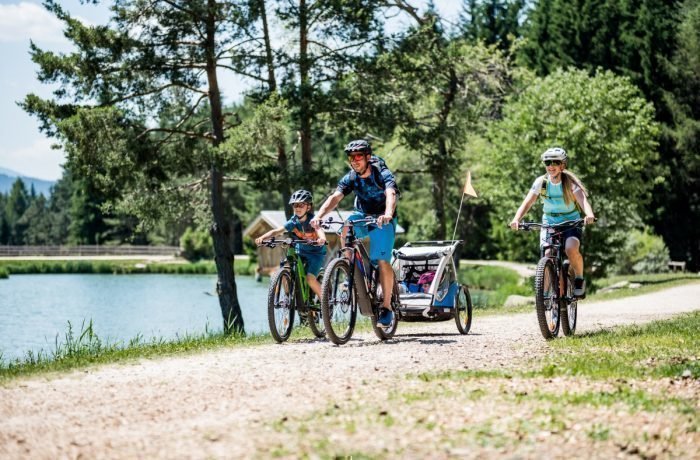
top-left (243, 211), bottom-right (404, 274)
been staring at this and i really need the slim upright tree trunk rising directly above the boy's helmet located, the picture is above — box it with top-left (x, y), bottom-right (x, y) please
top-left (299, 0), bottom-right (311, 177)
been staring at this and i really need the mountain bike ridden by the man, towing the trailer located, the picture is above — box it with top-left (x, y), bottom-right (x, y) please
top-left (321, 217), bottom-right (400, 345)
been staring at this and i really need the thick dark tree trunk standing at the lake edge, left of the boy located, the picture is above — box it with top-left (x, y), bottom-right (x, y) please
top-left (206, 0), bottom-right (245, 334)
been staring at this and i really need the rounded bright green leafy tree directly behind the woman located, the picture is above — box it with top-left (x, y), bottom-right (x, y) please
top-left (479, 70), bottom-right (660, 276)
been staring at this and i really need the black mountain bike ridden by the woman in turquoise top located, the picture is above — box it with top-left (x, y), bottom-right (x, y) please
top-left (518, 219), bottom-right (584, 340)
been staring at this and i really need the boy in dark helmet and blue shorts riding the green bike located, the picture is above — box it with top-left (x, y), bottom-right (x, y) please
top-left (255, 190), bottom-right (326, 299)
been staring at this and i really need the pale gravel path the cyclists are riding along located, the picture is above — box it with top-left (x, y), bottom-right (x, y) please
top-left (0, 284), bottom-right (700, 459)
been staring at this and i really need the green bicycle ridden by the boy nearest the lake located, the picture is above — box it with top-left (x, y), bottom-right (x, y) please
top-left (260, 238), bottom-right (326, 343)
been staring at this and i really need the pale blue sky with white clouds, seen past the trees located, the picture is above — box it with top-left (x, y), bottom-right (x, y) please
top-left (0, 0), bottom-right (462, 180)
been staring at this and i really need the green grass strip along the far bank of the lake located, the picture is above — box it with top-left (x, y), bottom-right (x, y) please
top-left (0, 260), bottom-right (255, 277)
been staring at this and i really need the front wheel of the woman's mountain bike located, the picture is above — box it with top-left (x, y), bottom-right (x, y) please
top-left (535, 257), bottom-right (559, 340)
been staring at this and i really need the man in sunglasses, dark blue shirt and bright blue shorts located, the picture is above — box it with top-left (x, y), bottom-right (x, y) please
top-left (311, 139), bottom-right (399, 327)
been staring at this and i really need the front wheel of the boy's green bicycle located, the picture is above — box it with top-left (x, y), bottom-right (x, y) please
top-left (267, 268), bottom-right (294, 343)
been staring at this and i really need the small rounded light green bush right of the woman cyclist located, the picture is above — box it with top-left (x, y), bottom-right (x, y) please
top-left (615, 229), bottom-right (671, 275)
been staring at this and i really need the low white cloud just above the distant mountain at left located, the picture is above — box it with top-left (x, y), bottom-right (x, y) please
top-left (0, 138), bottom-right (66, 180)
